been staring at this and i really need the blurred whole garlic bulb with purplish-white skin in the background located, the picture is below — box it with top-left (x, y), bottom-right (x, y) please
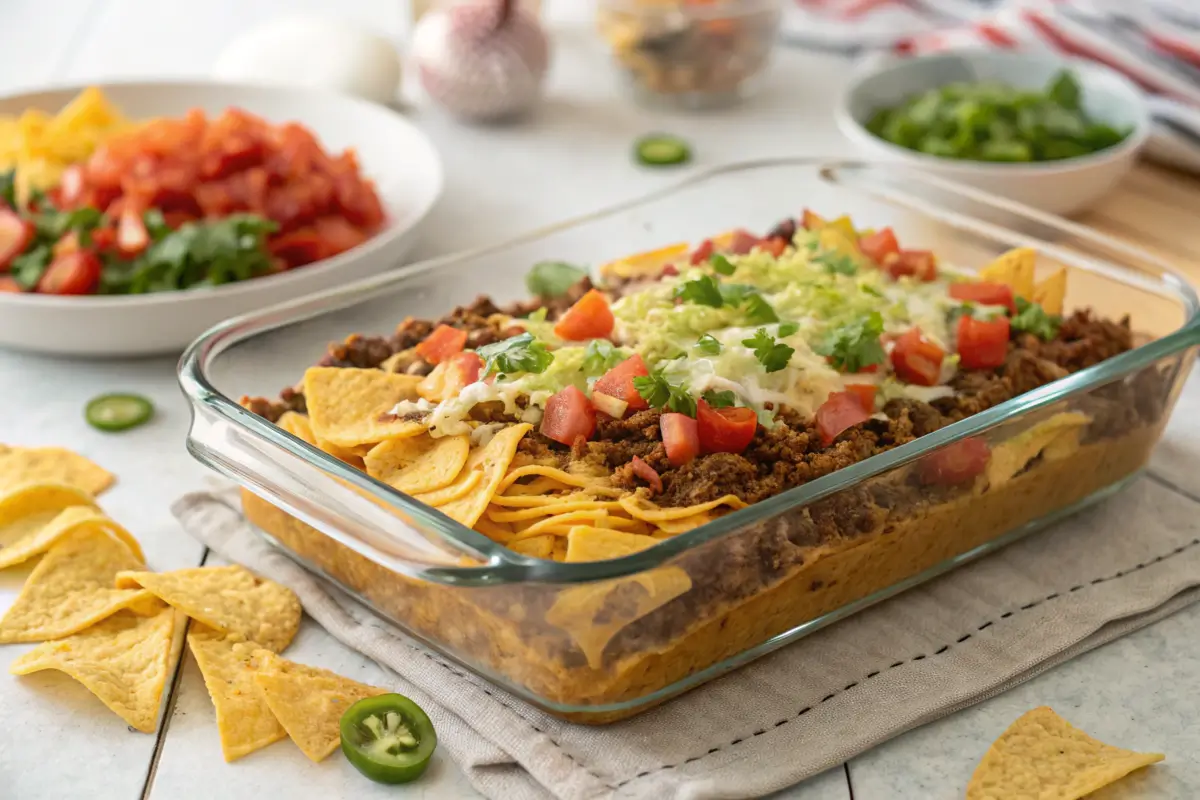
top-left (412, 0), bottom-right (550, 121)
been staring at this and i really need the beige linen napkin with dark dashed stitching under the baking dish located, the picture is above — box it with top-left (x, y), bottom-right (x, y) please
top-left (174, 412), bottom-right (1200, 800)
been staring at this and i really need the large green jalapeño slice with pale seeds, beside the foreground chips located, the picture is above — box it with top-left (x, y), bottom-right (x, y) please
top-left (341, 694), bottom-right (438, 783)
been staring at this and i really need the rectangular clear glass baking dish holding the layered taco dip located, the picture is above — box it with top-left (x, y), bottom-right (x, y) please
top-left (180, 158), bottom-right (1200, 723)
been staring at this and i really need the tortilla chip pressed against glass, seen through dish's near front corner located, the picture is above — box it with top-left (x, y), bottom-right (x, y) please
top-left (546, 566), bottom-right (691, 669)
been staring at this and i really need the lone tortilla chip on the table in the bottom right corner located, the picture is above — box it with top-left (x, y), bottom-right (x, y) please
top-left (967, 705), bottom-right (1164, 800)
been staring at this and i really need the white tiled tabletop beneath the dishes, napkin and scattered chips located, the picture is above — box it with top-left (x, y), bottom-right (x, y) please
top-left (0, 0), bottom-right (1200, 800)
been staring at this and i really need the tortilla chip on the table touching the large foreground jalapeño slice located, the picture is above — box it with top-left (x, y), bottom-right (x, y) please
top-left (254, 650), bottom-right (389, 762)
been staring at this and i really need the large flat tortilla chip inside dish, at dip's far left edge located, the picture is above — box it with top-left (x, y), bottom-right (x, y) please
top-left (304, 367), bottom-right (428, 447)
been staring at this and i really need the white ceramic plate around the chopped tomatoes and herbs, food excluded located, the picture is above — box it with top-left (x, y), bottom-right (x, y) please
top-left (0, 82), bottom-right (442, 356)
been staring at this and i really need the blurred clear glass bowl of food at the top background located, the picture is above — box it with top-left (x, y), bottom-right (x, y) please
top-left (596, 0), bottom-right (781, 108)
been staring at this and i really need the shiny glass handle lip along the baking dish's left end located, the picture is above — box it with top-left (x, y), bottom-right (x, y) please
top-left (187, 408), bottom-right (499, 582)
